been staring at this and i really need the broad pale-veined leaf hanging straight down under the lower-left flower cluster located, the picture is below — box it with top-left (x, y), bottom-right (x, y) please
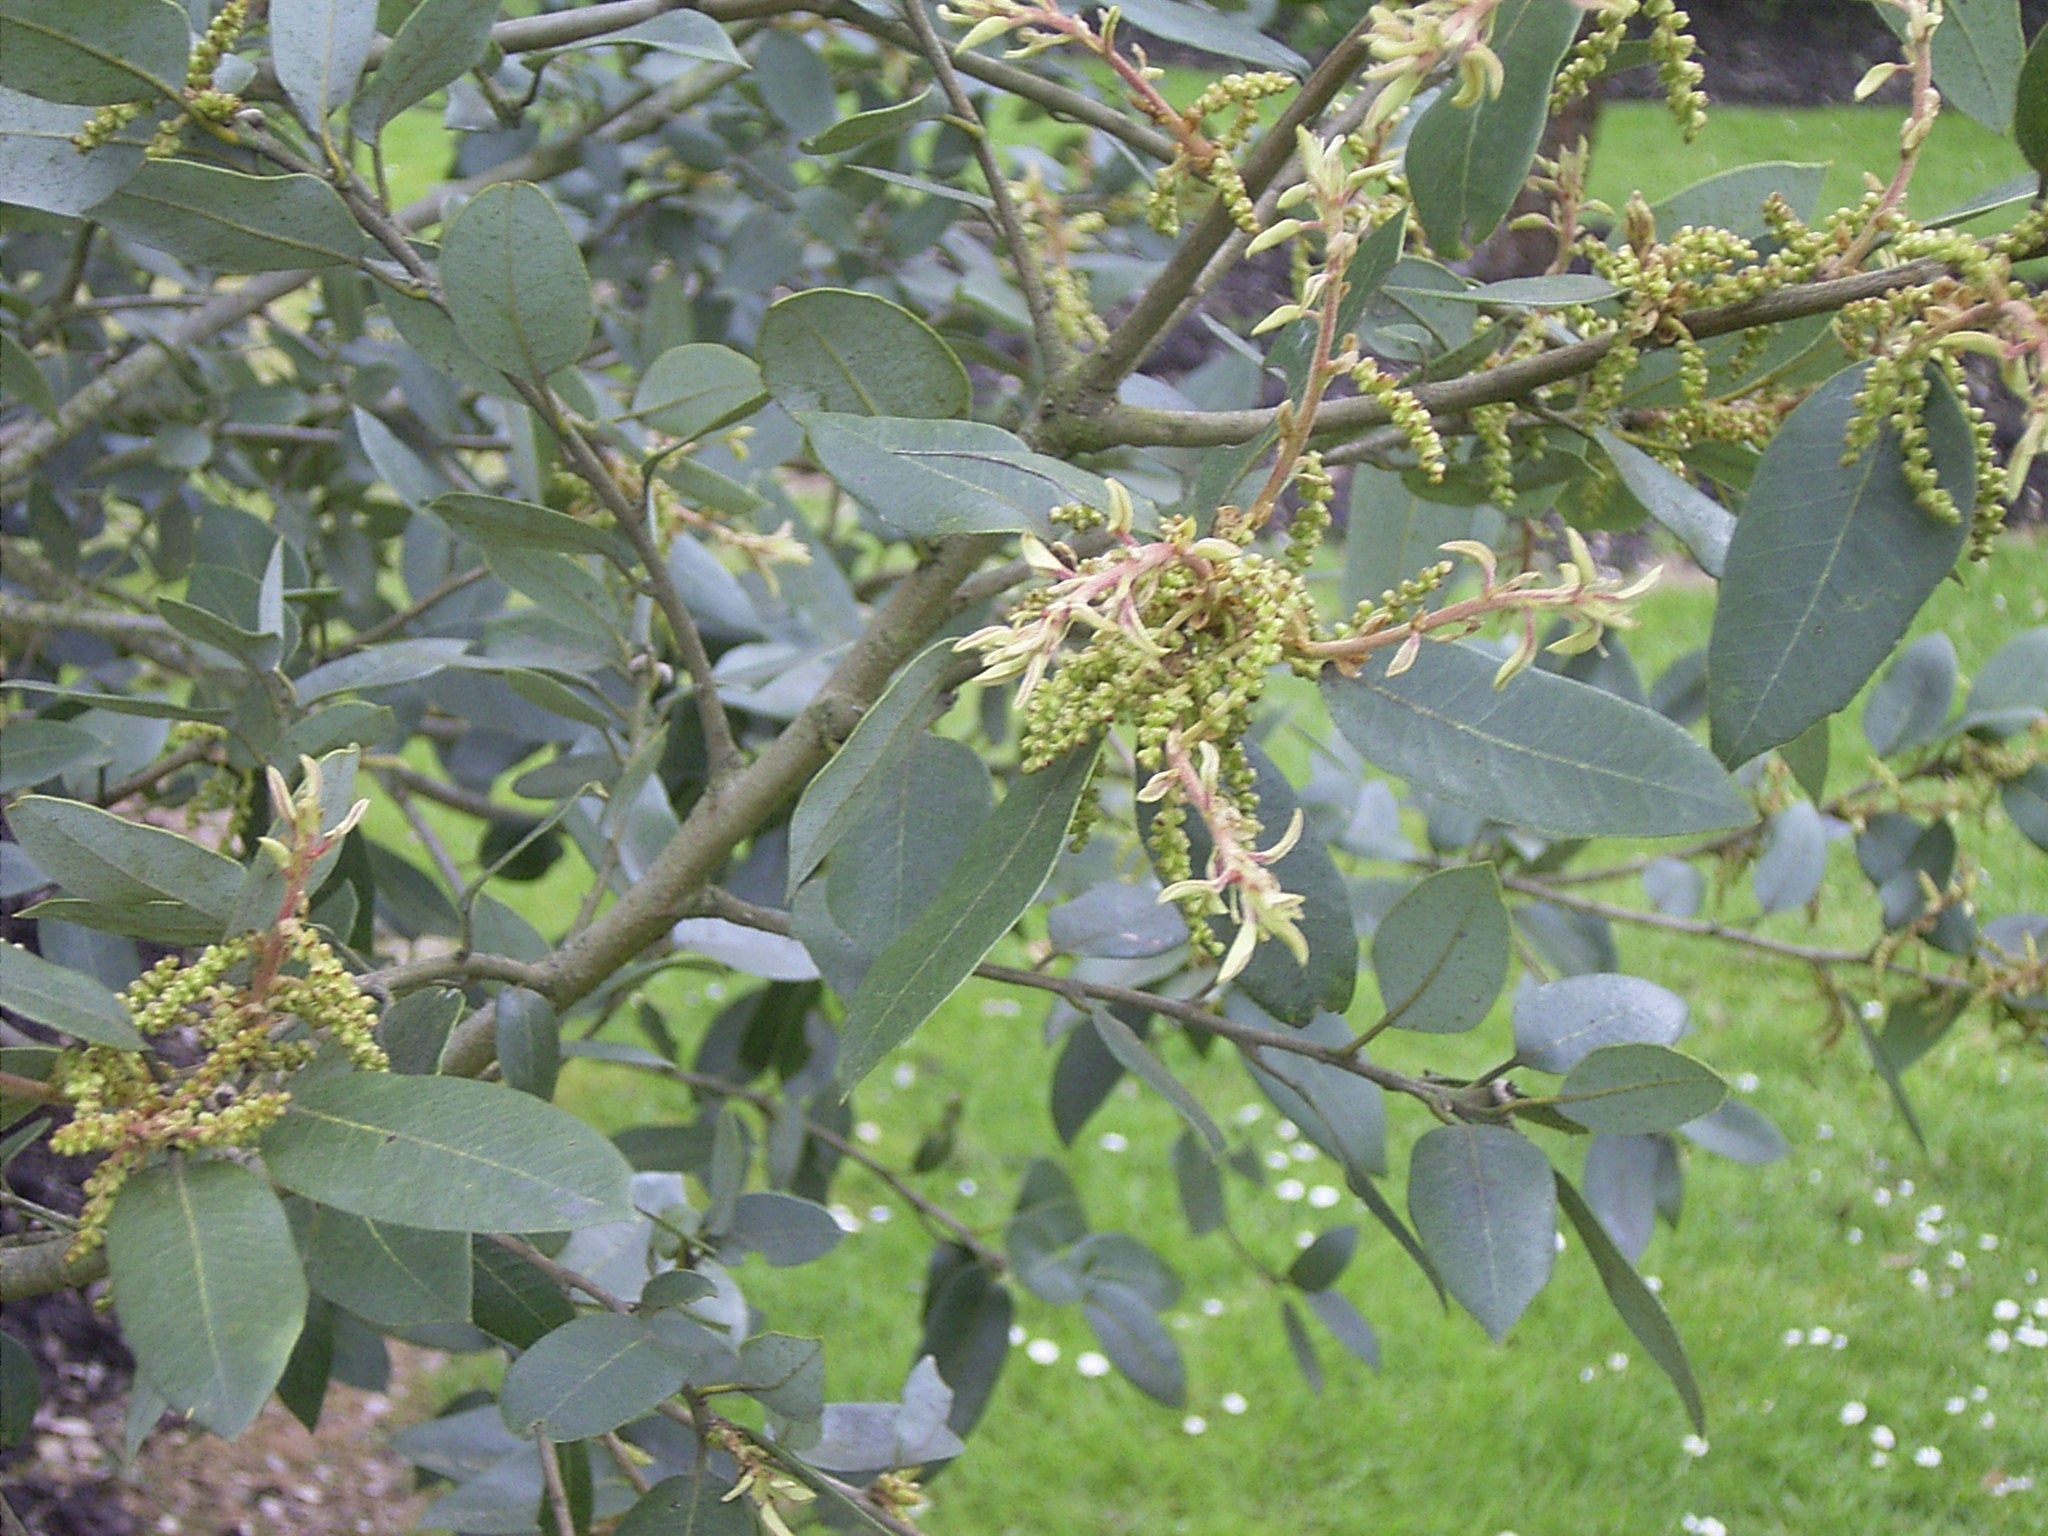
top-left (106, 1157), bottom-right (305, 1440)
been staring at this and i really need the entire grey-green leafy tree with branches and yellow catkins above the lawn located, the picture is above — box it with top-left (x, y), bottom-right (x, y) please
top-left (0, 0), bottom-right (2048, 1536)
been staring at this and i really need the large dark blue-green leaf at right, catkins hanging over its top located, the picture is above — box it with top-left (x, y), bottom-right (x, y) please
top-left (1706, 367), bottom-right (1976, 766)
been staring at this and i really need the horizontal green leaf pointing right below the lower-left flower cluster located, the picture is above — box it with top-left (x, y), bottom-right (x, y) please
top-left (262, 1073), bottom-right (633, 1233)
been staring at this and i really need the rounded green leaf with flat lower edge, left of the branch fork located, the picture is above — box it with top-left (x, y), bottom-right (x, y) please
top-left (754, 289), bottom-right (975, 420)
